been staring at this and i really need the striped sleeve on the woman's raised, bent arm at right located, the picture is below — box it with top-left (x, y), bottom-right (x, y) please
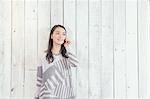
top-left (66, 47), bottom-right (79, 67)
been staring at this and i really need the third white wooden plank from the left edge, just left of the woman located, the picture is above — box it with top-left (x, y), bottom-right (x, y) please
top-left (24, 0), bottom-right (38, 99)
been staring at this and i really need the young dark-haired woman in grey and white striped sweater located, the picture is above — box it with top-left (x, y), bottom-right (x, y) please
top-left (36, 25), bottom-right (78, 99)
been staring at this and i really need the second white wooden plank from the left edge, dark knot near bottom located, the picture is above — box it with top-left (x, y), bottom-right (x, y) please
top-left (11, 0), bottom-right (24, 99)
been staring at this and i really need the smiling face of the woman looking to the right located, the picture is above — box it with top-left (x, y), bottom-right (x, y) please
top-left (51, 27), bottom-right (66, 45)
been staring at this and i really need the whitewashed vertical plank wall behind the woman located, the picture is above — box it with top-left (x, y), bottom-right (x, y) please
top-left (0, 0), bottom-right (150, 99)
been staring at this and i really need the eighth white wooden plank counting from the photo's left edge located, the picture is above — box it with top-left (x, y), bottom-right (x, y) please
top-left (87, 0), bottom-right (102, 99)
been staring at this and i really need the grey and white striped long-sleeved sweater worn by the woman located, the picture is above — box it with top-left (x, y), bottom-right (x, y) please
top-left (35, 48), bottom-right (78, 99)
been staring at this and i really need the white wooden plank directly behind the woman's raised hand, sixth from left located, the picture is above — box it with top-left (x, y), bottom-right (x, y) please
top-left (64, 0), bottom-right (77, 94)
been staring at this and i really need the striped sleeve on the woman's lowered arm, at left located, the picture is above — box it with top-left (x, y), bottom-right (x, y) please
top-left (35, 59), bottom-right (43, 99)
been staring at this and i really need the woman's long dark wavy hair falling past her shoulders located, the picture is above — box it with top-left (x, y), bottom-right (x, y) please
top-left (46, 25), bottom-right (68, 63)
